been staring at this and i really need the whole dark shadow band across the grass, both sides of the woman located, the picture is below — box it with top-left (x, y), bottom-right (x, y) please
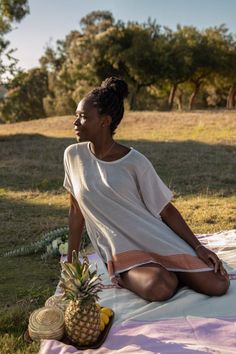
top-left (0, 134), bottom-right (236, 196)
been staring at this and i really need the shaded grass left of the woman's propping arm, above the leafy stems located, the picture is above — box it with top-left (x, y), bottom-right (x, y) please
top-left (0, 195), bottom-right (69, 250)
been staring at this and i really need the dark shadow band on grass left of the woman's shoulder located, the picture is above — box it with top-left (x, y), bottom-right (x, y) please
top-left (0, 134), bottom-right (75, 191)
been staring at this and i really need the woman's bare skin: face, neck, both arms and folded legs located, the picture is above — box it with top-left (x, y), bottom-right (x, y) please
top-left (68, 98), bottom-right (230, 301)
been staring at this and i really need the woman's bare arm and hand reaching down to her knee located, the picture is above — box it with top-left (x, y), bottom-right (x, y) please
top-left (160, 203), bottom-right (227, 276)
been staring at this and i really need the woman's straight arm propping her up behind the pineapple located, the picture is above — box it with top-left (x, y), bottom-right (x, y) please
top-left (67, 194), bottom-right (84, 262)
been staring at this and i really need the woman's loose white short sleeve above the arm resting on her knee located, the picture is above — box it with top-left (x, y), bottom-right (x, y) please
top-left (139, 163), bottom-right (173, 217)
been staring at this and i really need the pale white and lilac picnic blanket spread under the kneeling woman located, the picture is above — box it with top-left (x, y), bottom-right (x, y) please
top-left (39, 230), bottom-right (236, 354)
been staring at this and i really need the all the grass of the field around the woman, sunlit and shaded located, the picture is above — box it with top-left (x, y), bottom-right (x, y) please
top-left (0, 111), bottom-right (236, 354)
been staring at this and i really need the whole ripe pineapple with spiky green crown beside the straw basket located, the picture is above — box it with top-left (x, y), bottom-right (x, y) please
top-left (60, 251), bottom-right (101, 346)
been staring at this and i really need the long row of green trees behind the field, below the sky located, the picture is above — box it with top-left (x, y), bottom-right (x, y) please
top-left (0, 9), bottom-right (236, 122)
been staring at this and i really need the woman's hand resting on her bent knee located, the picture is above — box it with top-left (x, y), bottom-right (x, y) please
top-left (195, 245), bottom-right (228, 278)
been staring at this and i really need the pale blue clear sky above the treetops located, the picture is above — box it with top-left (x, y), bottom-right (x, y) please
top-left (4, 0), bottom-right (236, 69)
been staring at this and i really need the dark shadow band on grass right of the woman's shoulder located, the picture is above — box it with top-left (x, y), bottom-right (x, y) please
top-left (127, 140), bottom-right (236, 196)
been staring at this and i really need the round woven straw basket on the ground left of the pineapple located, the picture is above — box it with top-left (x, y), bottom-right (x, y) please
top-left (28, 307), bottom-right (64, 340)
